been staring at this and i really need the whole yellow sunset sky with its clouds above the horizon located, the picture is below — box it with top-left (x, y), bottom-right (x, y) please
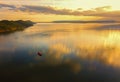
top-left (0, 0), bottom-right (120, 22)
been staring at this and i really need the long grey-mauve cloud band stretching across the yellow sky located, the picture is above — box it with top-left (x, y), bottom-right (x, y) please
top-left (0, 4), bottom-right (120, 17)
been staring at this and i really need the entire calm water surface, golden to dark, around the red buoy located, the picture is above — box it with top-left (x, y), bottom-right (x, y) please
top-left (0, 23), bottom-right (120, 82)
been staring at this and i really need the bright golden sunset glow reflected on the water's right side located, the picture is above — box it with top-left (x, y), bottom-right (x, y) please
top-left (24, 23), bottom-right (120, 72)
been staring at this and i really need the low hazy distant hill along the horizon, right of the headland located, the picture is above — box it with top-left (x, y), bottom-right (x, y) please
top-left (53, 20), bottom-right (116, 23)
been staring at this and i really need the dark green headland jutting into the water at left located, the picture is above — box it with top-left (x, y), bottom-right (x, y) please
top-left (0, 20), bottom-right (35, 33)
